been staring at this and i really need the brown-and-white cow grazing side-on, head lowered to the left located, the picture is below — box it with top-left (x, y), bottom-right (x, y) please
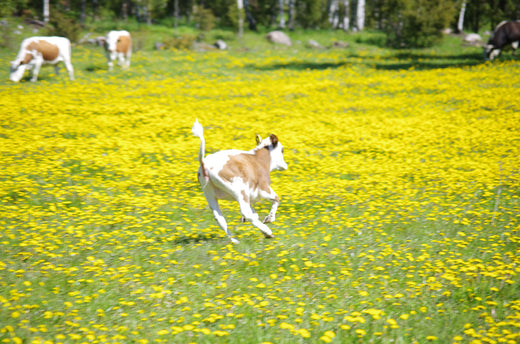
top-left (9, 36), bottom-right (74, 82)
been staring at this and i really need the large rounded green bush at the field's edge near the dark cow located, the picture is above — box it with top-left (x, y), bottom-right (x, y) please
top-left (384, 0), bottom-right (456, 48)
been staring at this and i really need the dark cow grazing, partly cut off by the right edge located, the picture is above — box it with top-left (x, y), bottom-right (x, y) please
top-left (484, 20), bottom-right (520, 60)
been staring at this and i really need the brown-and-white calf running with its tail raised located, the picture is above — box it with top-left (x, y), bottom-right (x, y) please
top-left (192, 120), bottom-right (287, 244)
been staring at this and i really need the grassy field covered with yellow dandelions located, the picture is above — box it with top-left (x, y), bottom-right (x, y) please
top-left (0, 27), bottom-right (520, 344)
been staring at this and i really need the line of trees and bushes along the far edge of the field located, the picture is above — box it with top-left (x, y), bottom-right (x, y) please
top-left (0, 0), bottom-right (520, 47)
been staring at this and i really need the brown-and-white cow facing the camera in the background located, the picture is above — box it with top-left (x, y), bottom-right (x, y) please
top-left (100, 30), bottom-right (132, 70)
